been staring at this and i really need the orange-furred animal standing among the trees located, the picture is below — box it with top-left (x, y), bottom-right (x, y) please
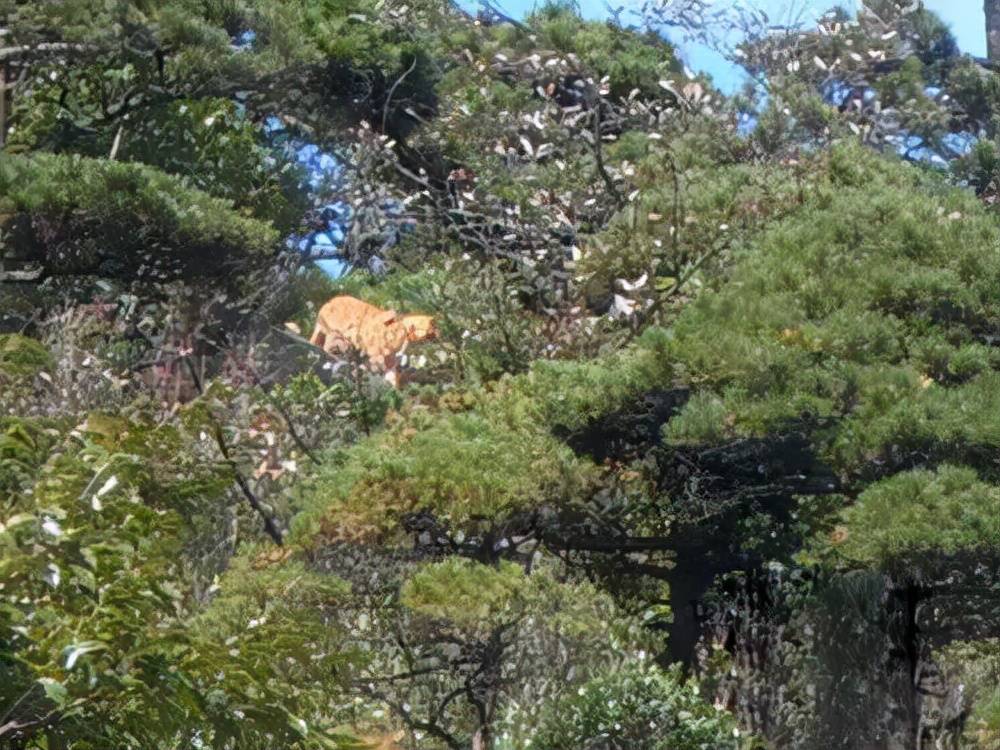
top-left (309, 296), bottom-right (437, 388)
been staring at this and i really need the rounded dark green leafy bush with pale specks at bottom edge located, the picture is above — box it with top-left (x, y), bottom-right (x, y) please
top-left (531, 664), bottom-right (750, 750)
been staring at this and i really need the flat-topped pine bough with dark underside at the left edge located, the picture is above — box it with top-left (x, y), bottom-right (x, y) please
top-left (0, 154), bottom-right (277, 275)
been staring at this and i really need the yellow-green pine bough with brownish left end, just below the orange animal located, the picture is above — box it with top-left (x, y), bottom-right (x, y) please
top-left (293, 412), bottom-right (590, 541)
